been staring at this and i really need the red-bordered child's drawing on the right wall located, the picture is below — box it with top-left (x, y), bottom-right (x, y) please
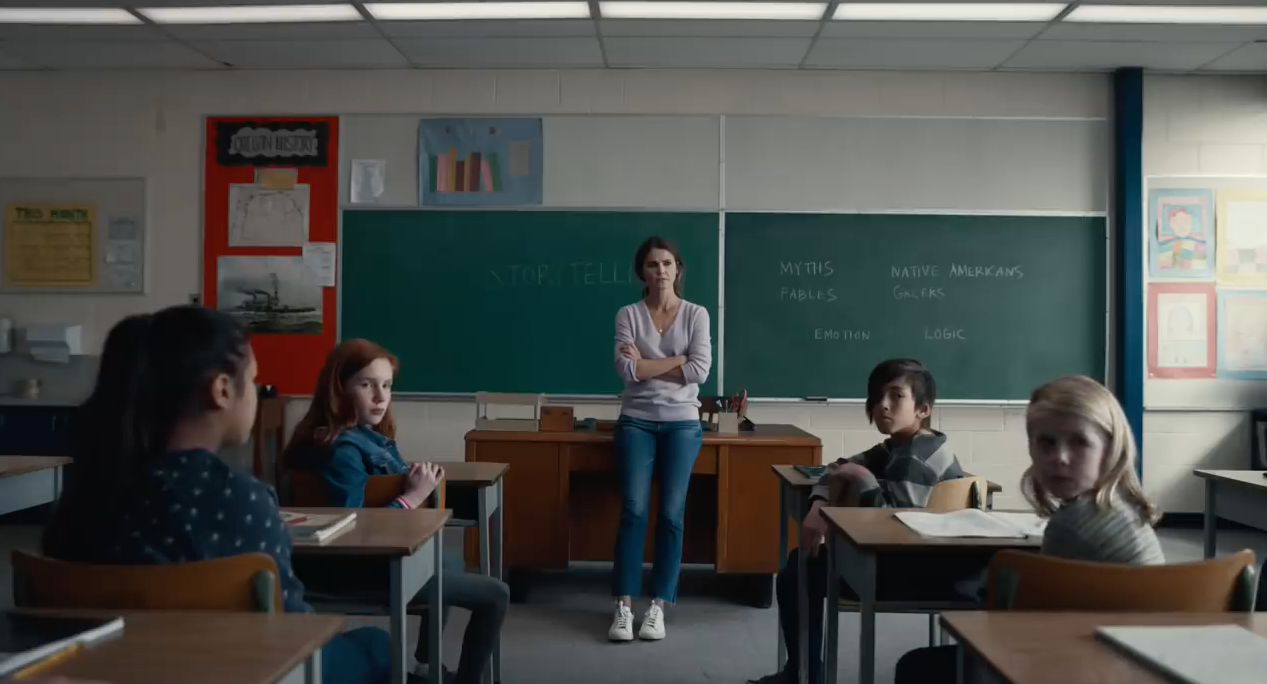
top-left (1148, 282), bottom-right (1215, 377)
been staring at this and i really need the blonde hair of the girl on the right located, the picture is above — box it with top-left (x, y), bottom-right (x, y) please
top-left (1021, 375), bottom-right (1161, 526)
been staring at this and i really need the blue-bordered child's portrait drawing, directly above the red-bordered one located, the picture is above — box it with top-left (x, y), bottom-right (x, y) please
top-left (1148, 189), bottom-right (1214, 277)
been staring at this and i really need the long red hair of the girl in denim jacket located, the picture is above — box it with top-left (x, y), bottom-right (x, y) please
top-left (286, 339), bottom-right (399, 460)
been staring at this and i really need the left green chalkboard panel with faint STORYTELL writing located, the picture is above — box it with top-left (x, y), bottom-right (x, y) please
top-left (340, 209), bottom-right (718, 394)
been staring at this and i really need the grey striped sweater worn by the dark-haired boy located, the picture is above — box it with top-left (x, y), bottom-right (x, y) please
top-left (810, 429), bottom-right (963, 508)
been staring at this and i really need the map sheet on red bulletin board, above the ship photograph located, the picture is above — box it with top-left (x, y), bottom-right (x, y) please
top-left (229, 184), bottom-right (308, 247)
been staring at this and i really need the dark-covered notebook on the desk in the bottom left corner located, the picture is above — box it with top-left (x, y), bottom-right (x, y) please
top-left (0, 613), bottom-right (123, 679)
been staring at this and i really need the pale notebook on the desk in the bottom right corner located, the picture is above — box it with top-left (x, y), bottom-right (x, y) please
top-left (1096, 624), bottom-right (1267, 684)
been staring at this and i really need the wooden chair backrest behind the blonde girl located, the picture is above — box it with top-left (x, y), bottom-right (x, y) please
top-left (986, 548), bottom-right (1257, 613)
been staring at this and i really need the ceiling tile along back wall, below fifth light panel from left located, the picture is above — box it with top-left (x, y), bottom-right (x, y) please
top-left (806, 38), bottom-right (1025, 70)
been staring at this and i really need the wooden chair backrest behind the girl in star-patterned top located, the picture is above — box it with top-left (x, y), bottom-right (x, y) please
top-left (11, 551), bottom-right (281, 613)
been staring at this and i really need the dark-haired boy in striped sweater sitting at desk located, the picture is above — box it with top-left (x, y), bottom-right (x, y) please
top-left (751, 358), bottom-right (963, 684)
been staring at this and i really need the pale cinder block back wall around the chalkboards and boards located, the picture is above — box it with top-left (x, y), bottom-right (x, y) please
top-left (0, 71), bottom-right (1251, 510)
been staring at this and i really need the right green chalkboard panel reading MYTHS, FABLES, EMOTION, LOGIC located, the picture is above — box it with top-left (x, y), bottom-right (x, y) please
top-left (723, 213), bottom-right (1106, 400)
